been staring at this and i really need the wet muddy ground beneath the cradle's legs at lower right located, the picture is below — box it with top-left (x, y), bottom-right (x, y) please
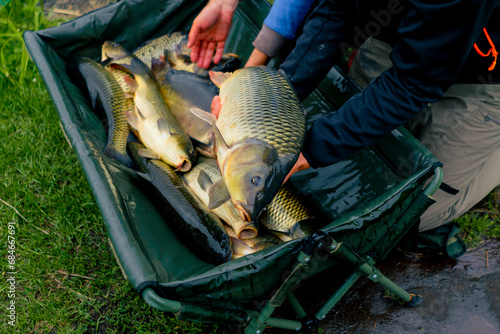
top-left (265, 240), bottom-right (500, 334)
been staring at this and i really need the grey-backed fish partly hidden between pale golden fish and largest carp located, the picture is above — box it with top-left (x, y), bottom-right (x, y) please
top-left (153, 62), bottom-right (219, 158)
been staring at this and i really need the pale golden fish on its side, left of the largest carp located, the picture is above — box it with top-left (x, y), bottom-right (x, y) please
top-left (110, 55), bottom-right (195, 172)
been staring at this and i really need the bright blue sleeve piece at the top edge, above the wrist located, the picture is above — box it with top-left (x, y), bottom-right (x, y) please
top-left (264, 0), bottom-right (314, 39)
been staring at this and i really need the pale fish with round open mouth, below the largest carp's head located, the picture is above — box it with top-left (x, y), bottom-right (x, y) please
top-left (181, 157), bottom-right (258, 239)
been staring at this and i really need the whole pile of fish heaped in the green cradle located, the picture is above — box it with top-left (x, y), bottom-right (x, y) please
top-left (77, 32), bottom-right (317, 264)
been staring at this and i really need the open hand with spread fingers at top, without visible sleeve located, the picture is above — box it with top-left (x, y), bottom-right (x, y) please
top-left (187, 0), bottom-right (239, 68)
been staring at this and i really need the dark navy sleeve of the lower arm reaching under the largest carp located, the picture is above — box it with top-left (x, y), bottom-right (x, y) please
top-left (298, 0), bottom-right (495, 167)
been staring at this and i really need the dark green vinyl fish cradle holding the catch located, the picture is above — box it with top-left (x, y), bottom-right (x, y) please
top-left (24, 0), bottom-right (440, 328)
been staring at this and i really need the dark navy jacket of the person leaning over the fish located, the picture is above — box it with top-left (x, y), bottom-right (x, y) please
top-left (281, 0), bottom-right (500, 167)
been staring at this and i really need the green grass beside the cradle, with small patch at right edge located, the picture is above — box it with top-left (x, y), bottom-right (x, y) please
top-left (0, 0), bottom-right (500, 333)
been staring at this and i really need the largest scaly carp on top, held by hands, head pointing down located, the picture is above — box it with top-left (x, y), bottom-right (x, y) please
top-left (191, 66), bottom-right (306, 221)
